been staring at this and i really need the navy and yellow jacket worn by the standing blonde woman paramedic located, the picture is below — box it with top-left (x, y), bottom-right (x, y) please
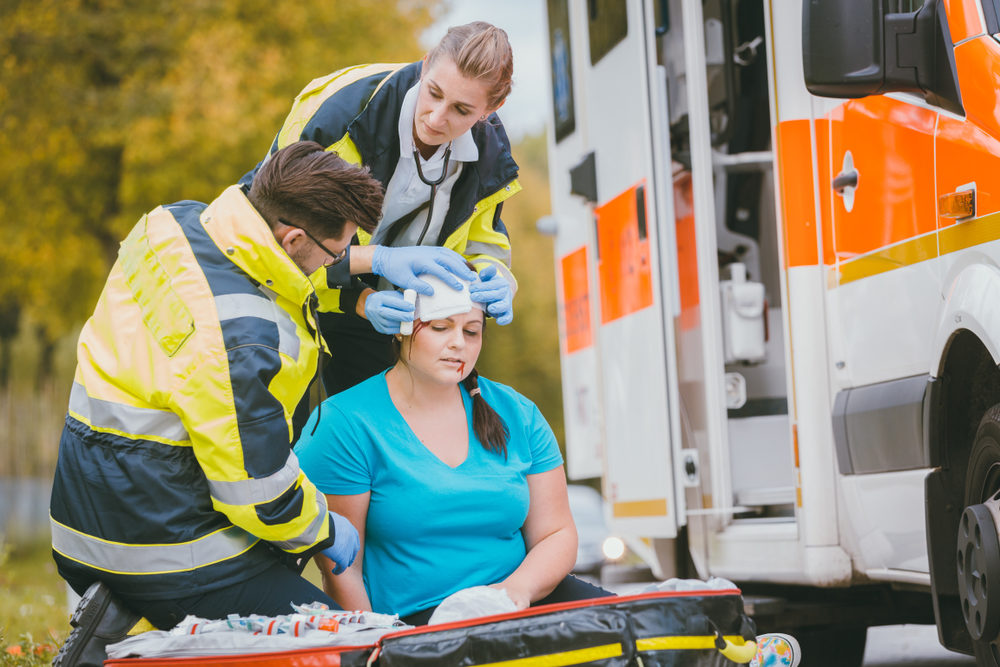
top-left (241, 61), bottom-right (521, 312)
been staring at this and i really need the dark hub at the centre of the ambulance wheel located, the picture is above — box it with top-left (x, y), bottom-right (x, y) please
top-left (958, 500), bottom-right (1000, 641)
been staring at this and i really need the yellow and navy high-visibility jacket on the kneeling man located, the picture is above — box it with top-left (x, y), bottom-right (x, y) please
top-left (51, 186), bottom-right (332, 599)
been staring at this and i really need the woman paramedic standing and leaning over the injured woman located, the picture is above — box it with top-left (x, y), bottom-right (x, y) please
top-left (242, 21), bottom-right (521, 393)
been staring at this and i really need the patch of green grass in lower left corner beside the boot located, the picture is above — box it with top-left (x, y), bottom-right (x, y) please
top-left (0, 542), bottom-right (70, 666)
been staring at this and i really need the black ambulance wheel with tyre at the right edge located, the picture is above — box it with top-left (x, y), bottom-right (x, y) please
top-left (957, 405), bottom-right (1000, 667)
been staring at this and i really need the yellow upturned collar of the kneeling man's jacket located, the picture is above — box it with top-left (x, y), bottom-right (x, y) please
top-left (201, 185), bottom-right (313, 305)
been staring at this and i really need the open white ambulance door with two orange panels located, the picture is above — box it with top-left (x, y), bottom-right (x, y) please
top-left (548, 0), bottom-right (685, 552)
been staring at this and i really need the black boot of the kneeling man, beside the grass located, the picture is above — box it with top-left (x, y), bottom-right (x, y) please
top-left (52, 581), bottom-right (139, 667)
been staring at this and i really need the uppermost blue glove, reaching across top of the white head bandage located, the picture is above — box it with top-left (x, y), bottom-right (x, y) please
top-left (372, 246), bottom-right (476, 294)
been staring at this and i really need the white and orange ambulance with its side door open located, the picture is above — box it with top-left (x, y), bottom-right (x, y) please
top-left (539, 0), bottom-right (1000, 667)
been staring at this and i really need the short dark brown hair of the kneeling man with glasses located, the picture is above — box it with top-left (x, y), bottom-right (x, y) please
top-left (247, 141), bottom-right (383, 239)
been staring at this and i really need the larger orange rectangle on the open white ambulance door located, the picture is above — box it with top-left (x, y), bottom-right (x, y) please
top-left (594, 182), bottom-right (653, 324)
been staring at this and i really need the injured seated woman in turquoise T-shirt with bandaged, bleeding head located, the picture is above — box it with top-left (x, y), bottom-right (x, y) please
top-left (295, 278), bottom-right (611, 625)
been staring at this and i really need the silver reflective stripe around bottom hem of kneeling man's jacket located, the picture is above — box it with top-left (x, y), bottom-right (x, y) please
top-left (49, 517), bottom-right (258, 574)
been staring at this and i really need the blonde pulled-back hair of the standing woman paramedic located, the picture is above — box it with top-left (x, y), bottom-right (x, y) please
top-left (427, 21), bottom-right (514, 109)
